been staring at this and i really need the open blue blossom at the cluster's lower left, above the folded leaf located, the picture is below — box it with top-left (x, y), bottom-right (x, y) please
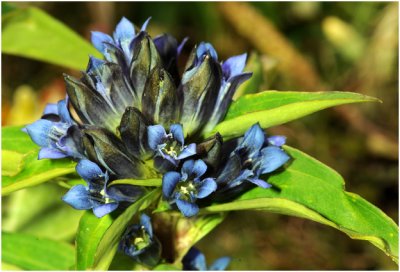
top-left (62, 160), bottom-right (143, 217)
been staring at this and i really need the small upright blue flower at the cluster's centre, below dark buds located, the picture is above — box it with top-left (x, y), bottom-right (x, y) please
top-left (147, 124), bottom-right (196, 166)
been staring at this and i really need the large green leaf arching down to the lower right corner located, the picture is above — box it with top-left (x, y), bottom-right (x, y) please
top-left (203, 146), bottom-right (398, 262)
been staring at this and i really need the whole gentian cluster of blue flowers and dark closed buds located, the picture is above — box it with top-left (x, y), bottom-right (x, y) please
top-left (24, 18), bottom-right (289, 269)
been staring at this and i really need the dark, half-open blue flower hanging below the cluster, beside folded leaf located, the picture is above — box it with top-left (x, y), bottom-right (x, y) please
top-left (119, 214), bottom-right (161, 267)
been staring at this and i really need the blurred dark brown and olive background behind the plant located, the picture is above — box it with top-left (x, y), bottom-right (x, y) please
top-left (1, 2), bottom-right (399, 270)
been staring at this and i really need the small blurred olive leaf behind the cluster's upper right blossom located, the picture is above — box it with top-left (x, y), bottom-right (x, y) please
top-left (233, 52), bottom-right (263, 100)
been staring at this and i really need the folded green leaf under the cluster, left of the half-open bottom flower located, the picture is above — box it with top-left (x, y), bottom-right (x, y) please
top-left (76, 189), bottom-right (160, 270)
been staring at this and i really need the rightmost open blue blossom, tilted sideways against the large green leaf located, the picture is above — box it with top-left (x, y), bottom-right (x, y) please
top-left (217, 124), bottom-right (290, 191)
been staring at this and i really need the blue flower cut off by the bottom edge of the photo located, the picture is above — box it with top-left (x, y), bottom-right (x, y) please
top-left (182, 247), bottom-right (231, 271)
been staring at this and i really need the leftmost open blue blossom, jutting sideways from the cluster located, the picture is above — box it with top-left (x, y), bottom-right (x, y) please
top-left (23, 99), bottom-right (84, 160)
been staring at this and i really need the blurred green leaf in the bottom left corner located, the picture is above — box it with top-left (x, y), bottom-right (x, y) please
top-left (1, 232), bottom-right (75, 270)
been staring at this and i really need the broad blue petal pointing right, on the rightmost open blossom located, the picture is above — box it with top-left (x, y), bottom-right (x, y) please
top-left (260, 146), bottom-right (290, 174)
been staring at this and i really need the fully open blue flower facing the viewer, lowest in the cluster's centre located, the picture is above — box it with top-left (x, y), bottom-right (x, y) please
top-left (162, 160), bottom-right (217, 217)
